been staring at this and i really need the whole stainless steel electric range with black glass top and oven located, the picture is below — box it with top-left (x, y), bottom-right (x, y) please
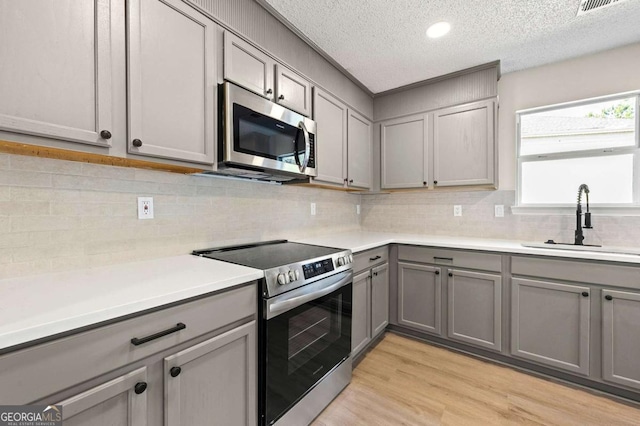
top-left (193, 240), bottom-right (353, 425)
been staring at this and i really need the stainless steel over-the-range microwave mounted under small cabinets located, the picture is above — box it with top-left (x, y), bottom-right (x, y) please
top-left (218, 82), bottom-right (317, 182)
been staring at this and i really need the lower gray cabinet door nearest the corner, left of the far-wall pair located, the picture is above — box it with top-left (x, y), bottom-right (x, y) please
top-left (398, 262), bottom-right (442, 335)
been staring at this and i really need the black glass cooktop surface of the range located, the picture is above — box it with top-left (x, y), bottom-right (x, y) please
top-left (193, 240), bottom-right (344, 270)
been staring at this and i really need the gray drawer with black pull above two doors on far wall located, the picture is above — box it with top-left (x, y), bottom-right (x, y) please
top-left (398, 246), bottom-right (502, 272)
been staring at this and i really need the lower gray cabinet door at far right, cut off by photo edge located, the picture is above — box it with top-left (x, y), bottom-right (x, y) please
top-left (602, 290), bottom-right (640, 389)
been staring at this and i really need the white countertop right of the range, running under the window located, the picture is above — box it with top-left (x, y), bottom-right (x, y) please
top-left (296, 231), bottom-right (640, 264)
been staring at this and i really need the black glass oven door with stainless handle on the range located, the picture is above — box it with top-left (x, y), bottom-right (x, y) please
top-left (260, 271), bottom-right (353, 425)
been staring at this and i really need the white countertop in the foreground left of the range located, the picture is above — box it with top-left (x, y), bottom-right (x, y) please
top-left (0, 255), bottom-right (264, 350)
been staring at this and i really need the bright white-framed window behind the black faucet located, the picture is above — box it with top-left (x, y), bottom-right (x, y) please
top-left (516, 92), bottom-right (640, 211)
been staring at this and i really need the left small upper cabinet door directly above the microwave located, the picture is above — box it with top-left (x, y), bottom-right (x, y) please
top-left (223, 31), bottom-right (275, 99)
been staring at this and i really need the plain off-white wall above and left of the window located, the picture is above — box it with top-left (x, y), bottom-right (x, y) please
top-left (498, 43), bottom-right (640, 190)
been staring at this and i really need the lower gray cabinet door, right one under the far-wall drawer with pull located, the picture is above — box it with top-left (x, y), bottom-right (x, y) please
top-left (447, 269), bottom-right (502, 351)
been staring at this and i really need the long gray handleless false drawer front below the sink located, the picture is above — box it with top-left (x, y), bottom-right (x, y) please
top-left (511, 256), bottom-right (640, 289)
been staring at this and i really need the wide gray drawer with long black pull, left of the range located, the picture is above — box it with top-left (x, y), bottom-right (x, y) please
top-left (0, 285), bottom-right (257, 404)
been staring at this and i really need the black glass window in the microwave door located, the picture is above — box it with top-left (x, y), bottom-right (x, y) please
top-left (233, 104), bottom-right (305, 164)
